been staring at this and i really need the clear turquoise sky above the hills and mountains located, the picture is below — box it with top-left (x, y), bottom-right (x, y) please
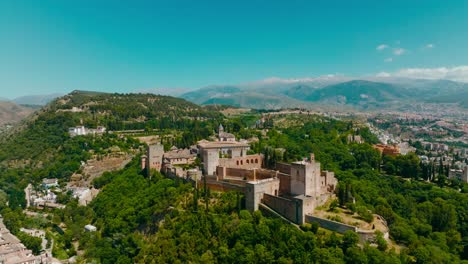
top-left (0, 0), bottom-right (468, 98)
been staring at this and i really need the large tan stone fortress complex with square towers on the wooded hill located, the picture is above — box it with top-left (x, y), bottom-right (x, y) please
top-left (141, 126), bottom-right (337, 224)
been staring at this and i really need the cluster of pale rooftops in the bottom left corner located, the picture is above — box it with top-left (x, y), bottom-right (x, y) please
top-left (0, 216), bottom-right (51, 264)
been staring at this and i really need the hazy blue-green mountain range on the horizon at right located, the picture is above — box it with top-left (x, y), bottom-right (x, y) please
top-left (180, 77), bottom-right (468, 109)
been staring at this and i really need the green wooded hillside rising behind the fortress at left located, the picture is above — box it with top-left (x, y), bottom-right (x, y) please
top-left (0, 91), bottom-right (223, 166)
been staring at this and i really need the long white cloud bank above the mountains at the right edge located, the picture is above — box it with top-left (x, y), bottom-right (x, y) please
top-left (377, 65), bottom-right (468, 82)
